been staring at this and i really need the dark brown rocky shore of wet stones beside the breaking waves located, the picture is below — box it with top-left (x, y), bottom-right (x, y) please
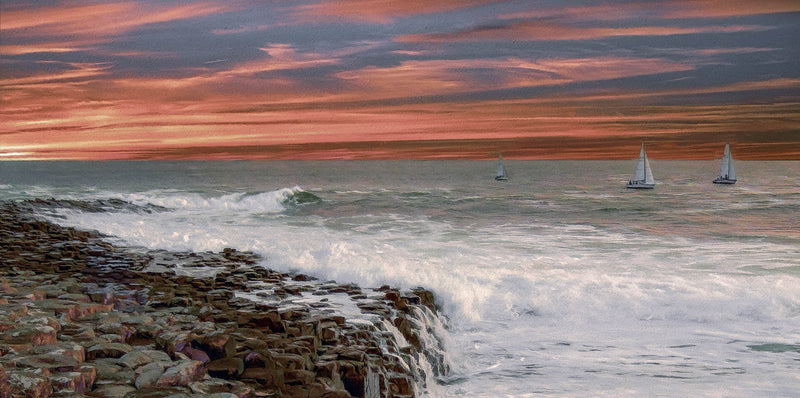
top-left (0, 200), bottom-right (448, 398)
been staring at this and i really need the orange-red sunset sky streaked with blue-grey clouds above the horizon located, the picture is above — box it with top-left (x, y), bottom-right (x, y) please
top-left (0, 0), bottom-right (800, 160)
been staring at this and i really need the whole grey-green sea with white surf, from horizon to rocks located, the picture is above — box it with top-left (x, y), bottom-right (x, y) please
top-left (0, 160), bottom-right (800, 397)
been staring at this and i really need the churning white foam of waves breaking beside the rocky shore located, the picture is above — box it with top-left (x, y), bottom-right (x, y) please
top-left (39, 183), bottom-right (800, 396)
